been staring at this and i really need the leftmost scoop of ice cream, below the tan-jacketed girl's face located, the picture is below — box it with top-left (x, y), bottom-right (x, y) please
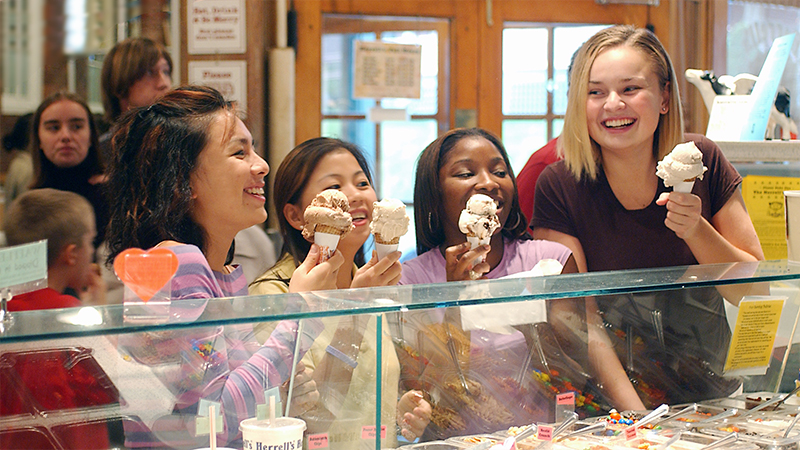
top-left (303, 189), bottom-right (355, 242)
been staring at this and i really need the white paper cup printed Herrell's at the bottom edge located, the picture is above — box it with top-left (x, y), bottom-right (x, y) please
top-left (239, 417), bottom-right (306, 450)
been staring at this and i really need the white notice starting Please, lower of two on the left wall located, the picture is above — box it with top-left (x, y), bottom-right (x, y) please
top-left (189, 61), bottom-right (247, 112)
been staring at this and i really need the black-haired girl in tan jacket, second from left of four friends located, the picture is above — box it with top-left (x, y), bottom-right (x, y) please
top-left (250, 138), bottom-right (430, 447)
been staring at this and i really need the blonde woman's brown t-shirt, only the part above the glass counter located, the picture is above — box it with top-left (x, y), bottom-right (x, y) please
top-left (531, 134), bottom-right (742, 272)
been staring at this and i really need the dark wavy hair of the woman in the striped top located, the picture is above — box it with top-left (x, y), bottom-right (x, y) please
top-left (107, 86), bottom-right (236, 264)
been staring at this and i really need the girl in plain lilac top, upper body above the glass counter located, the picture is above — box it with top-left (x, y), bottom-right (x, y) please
top-left (400, 128), bottom-right (578, 284)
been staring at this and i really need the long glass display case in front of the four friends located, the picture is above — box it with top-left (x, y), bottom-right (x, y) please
top-left (0, 261), bottom-right (800, 449)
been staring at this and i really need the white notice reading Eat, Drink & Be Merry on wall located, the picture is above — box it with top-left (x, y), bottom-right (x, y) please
top-left (186, 0), bottom-right (247, 55)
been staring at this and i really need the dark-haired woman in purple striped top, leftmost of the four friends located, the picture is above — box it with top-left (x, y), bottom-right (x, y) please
top-left (108, 86), bottom-right (342, 447)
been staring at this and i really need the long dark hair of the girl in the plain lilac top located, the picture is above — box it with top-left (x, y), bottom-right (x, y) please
top-left (414, 128), bottom-right (531, 255)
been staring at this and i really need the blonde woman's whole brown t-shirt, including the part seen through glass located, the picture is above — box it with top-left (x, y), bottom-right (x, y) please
top-left (532, 134), bottom-right (742, 408)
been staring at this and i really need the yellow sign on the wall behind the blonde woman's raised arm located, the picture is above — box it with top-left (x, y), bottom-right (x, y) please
top-left (742, 175), bottom-right (800, 259)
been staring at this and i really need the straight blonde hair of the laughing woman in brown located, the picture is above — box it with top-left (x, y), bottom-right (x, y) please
top-left (558, 25), bottom-right (683, 180)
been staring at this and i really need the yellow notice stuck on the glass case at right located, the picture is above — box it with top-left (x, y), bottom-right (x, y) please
top-left (725, 296), bottom-right (786, 375)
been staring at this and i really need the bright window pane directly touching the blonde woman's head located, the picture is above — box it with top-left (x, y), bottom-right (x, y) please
top-left (553, 25), bottom-right (608, 114)
